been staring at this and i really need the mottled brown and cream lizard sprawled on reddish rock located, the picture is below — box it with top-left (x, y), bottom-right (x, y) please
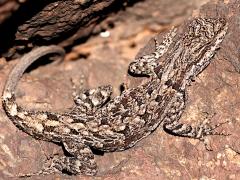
top-left (2, 17), bottom-right (228, 175)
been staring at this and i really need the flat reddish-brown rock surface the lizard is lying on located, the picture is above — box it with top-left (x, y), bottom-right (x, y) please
top-left (0, 0), bottom-right (240, 180)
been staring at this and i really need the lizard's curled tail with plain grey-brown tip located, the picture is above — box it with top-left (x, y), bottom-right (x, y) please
top-left (2, 45), bottom-right (65, 134)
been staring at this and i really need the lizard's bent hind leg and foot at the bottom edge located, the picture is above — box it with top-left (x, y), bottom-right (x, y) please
top-left (18, 140), bottom-right (97, 177)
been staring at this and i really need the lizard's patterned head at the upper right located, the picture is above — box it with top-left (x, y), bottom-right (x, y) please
top-left (178, 18), bottom-right (228, 88)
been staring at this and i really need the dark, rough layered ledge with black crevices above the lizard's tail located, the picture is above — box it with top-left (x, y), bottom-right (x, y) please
top-left (0, 0), bottom-right (137, 57)
